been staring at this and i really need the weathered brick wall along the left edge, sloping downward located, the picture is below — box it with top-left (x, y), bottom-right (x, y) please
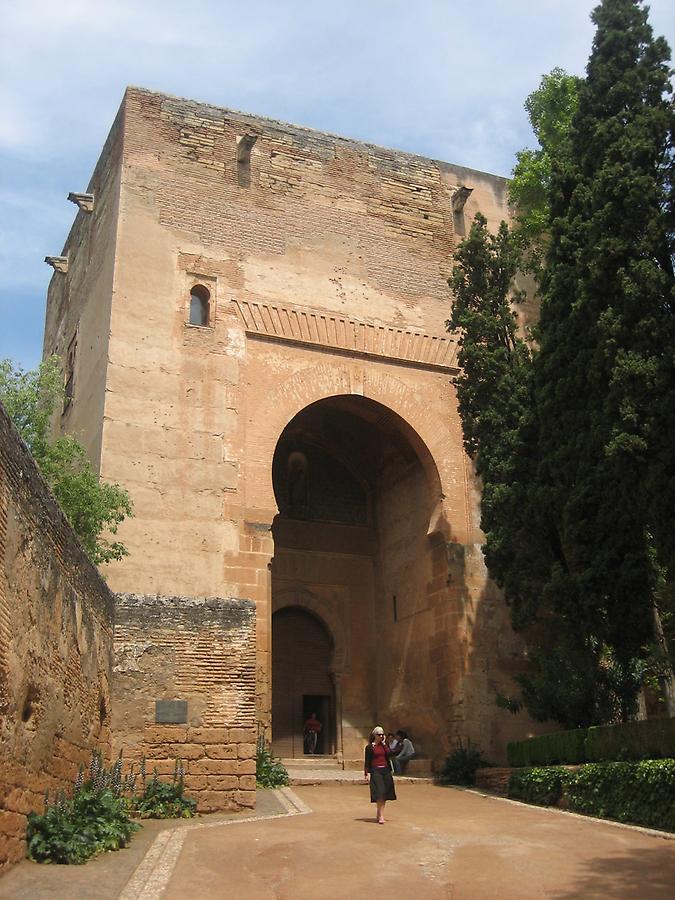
top-left (0, 406), bottom-right (114, 870)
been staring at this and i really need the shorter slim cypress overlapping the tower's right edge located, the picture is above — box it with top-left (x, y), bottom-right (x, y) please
top-left (446, 213), bottom-right (537, 625)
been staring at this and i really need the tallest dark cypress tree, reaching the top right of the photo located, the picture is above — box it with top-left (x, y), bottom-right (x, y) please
top-left (535, 0), bottom-right (675, 719)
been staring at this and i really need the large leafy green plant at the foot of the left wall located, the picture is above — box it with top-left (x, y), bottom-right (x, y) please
top-left (26, 753), bottom-right (139, 864)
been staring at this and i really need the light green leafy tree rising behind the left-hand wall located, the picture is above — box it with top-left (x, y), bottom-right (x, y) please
top-left (0, 357), bottom-right (133, 565)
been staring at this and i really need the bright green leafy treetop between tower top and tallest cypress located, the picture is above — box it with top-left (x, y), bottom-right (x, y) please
top-left (509, 68), bottom-right (580, 274)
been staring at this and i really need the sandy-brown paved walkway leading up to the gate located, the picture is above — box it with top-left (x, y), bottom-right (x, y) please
top-left (0, 783), bottom-right (675, 900)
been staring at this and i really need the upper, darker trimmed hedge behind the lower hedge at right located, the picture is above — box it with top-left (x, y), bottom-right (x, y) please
top-left (507, 719), bottom-right (675, 767)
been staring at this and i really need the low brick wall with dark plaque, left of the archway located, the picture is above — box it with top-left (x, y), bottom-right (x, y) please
top-left (113, 594), bottom-right (256, 812)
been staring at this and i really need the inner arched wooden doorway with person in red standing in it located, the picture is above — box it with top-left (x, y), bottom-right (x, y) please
top-left (272, 606), bottom-right (335, 758)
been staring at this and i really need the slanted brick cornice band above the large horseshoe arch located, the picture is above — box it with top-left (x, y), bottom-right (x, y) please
top-left (232, 300), bottom-right (458, 373)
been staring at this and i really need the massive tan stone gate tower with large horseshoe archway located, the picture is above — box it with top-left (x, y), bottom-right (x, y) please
top-left (44, 88), bottom-right (536, 761)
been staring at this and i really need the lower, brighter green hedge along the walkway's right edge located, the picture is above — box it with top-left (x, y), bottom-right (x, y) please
top-left (508, 759), bottom-right (675, 831)
